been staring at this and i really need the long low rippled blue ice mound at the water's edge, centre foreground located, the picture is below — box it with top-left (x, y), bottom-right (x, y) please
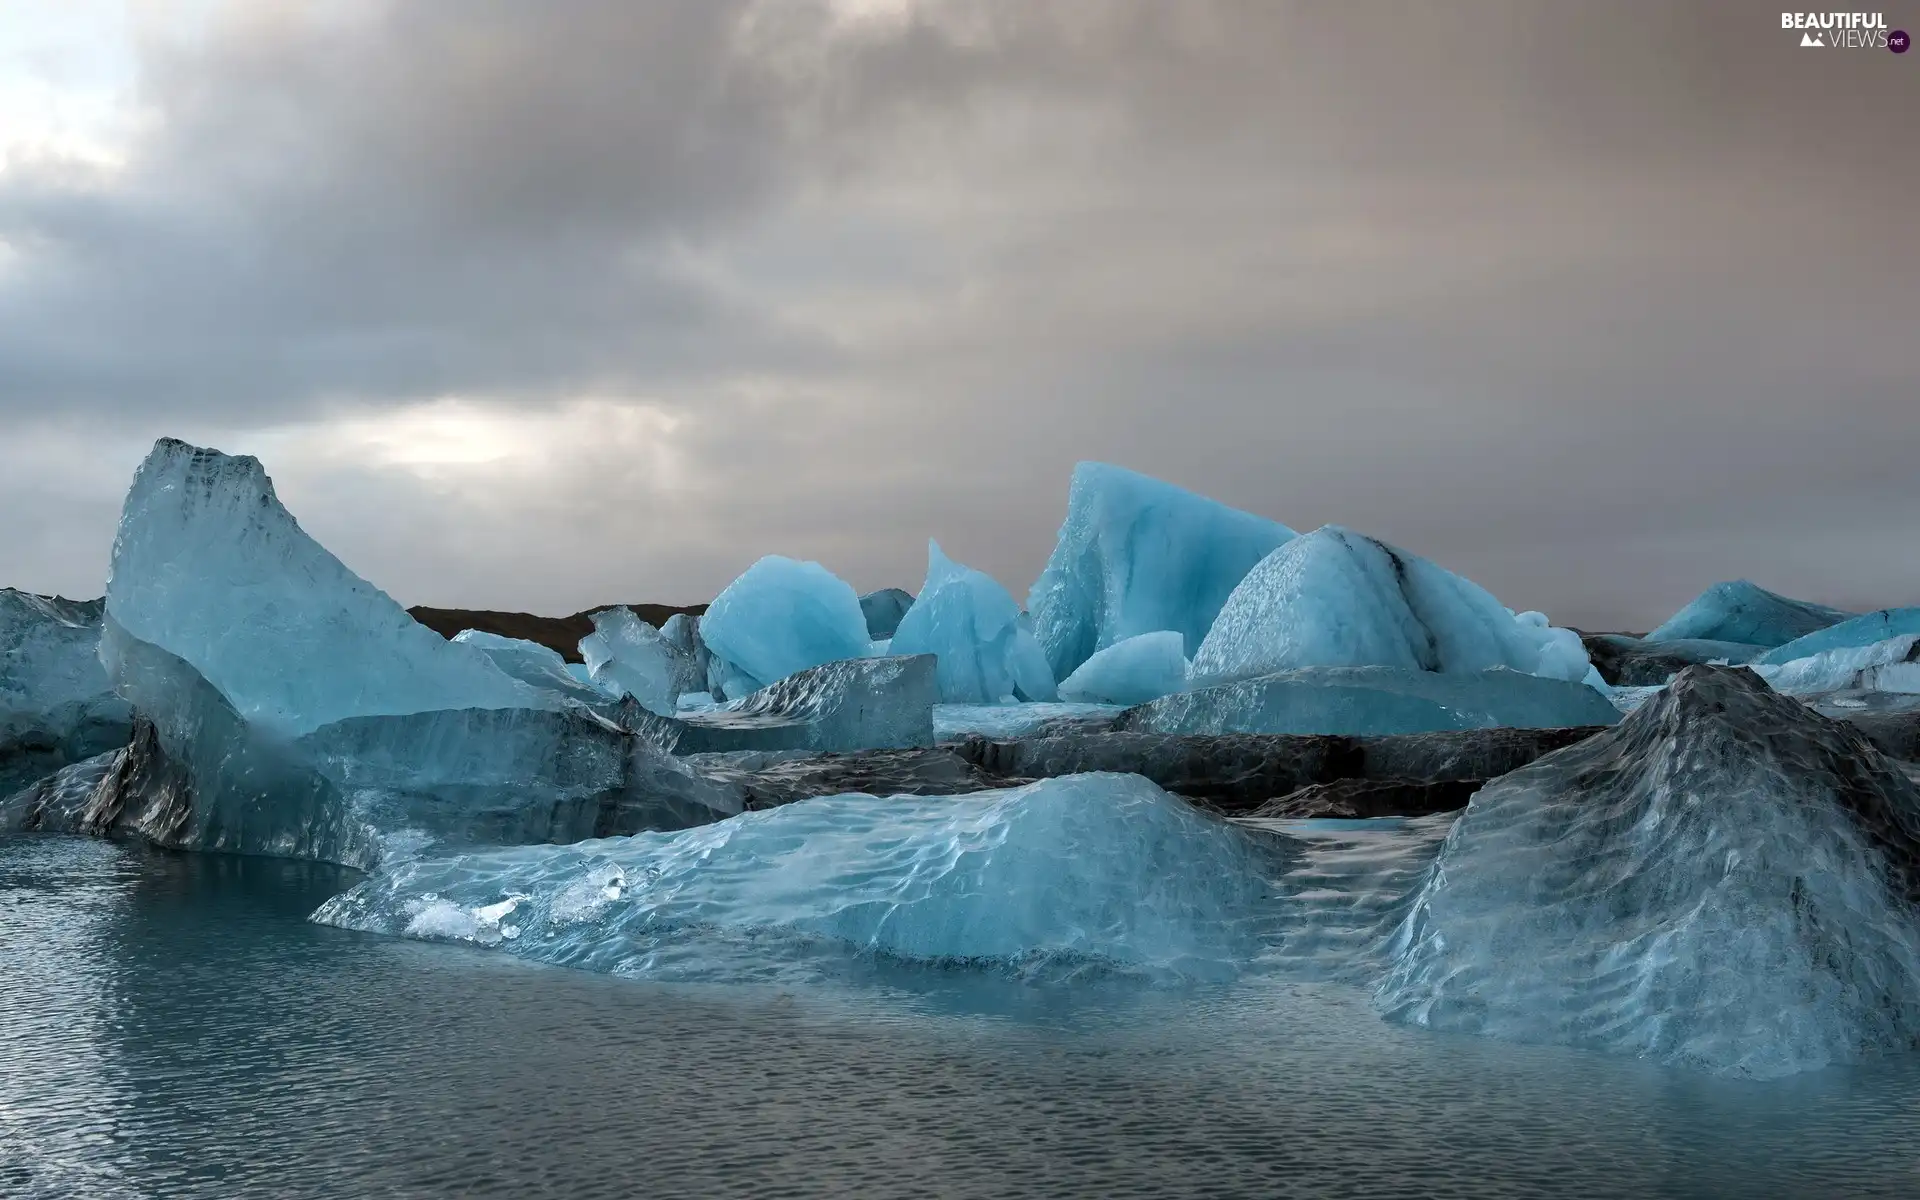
top-left (315, 774), bottom-right (1265, 981)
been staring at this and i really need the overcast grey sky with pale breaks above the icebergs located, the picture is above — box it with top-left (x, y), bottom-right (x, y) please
top-left (0, 0), bottom-right (1920, 628)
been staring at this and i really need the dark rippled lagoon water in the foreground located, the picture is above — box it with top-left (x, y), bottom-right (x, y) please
top-left (0, 837), bottom-right (1920, 1198)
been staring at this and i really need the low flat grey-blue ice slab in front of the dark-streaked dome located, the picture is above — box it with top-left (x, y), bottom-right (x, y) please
top-left (1116, 666), bottom-right (1620, 733)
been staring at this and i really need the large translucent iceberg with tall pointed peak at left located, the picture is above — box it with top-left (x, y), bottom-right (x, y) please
top-left (58, 440), bottom-right (737, 868)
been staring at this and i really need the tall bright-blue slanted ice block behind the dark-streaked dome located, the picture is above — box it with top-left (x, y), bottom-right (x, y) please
top-left (1027, 463), bottom-right (1294, 680)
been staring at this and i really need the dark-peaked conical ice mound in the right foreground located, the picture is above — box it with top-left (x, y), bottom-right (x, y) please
top-left (1377, 666), bottom-right (1920, 1079)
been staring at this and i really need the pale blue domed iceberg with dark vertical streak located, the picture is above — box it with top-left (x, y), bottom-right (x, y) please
top-left (1192, 526), bottom-right (1599, 682)
